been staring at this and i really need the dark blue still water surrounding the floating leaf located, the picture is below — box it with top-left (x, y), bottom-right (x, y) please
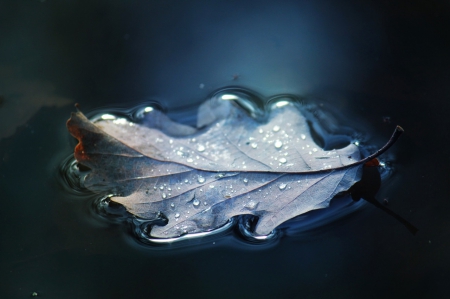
top-left (0, 0), bottom-right (450, 298)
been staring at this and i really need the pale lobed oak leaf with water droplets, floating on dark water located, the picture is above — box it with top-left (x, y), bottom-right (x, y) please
top-left (67, 96), bottom-right (401, 238)
